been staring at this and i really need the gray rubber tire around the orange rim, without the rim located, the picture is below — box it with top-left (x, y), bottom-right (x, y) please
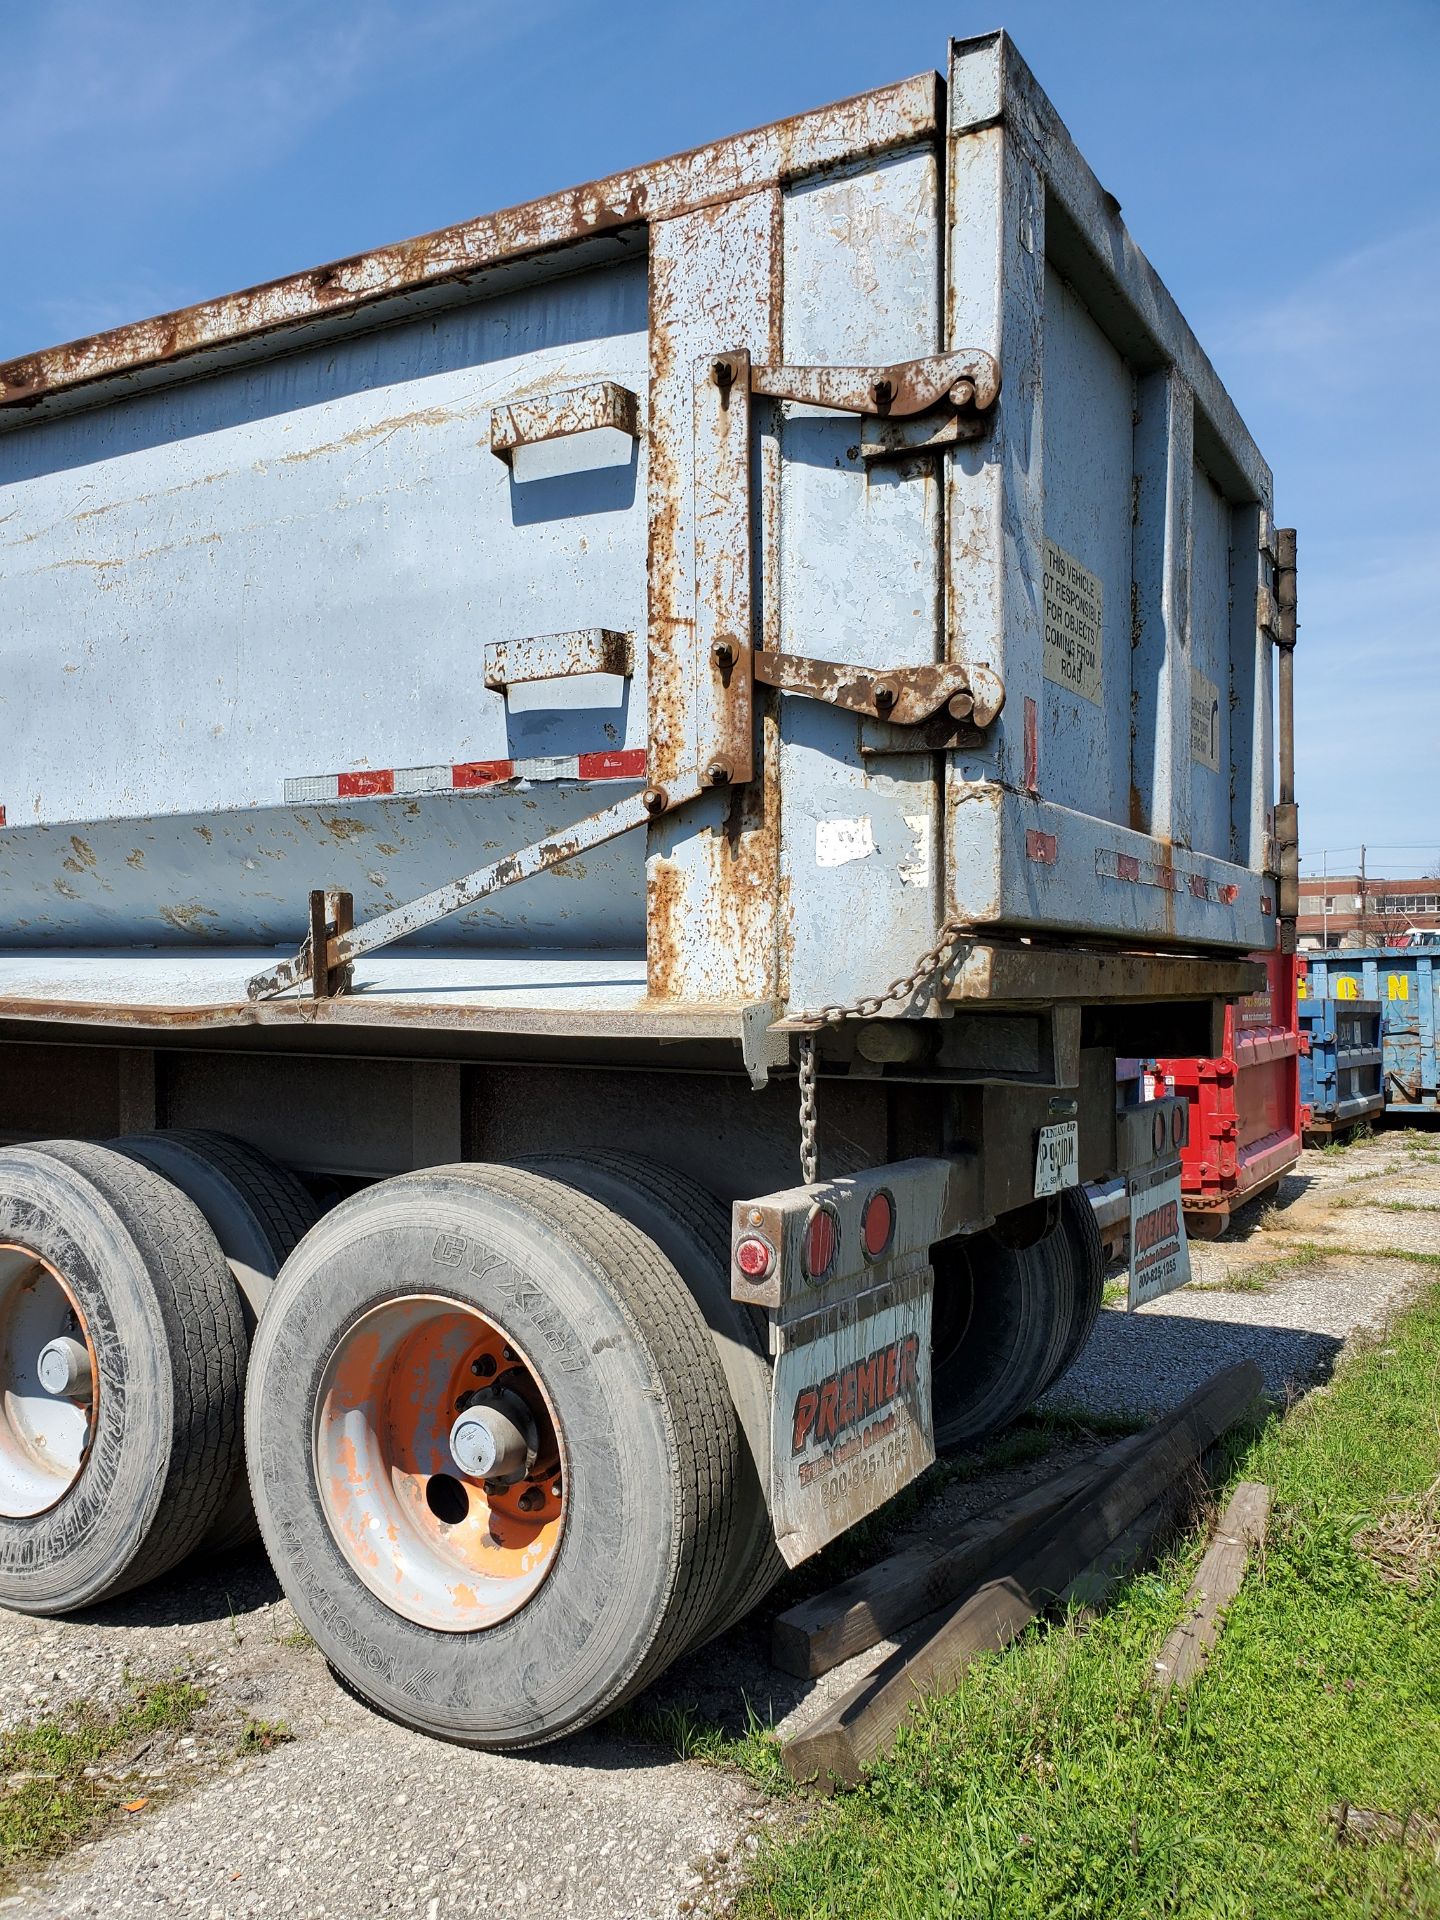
top-left (246, 1165), bottom-right (737, 1747)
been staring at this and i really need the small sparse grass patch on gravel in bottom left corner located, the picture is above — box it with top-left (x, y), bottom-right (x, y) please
top-left (0, 1680), bottom-right (205, 1885)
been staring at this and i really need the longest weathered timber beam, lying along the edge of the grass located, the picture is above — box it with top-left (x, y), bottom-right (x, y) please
top-left (783, 1361), bottom-right (1261, 1791)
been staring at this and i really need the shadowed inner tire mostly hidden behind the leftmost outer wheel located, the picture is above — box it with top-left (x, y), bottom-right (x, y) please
top-left (109, 1127), bottom-right (321, 1553)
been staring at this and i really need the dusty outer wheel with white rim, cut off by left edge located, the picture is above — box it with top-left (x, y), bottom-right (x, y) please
top-left (0, 1140), bottom-right (244, 1613)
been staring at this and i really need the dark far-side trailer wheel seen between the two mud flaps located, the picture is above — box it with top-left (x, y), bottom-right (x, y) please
top-left (929, 1225), bottom-right (1075, 1448)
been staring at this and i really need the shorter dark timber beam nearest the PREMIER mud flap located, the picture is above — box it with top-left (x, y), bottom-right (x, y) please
top-left (770, 1434), bottom-right (1139, 1680)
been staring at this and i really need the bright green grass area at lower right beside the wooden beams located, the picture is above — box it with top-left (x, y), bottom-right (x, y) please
top-left (739, 1284), bottom-right (1440, 1920)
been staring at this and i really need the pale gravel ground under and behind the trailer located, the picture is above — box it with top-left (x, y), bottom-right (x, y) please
top-left (0, 1135), bottom-right (1440, 1920)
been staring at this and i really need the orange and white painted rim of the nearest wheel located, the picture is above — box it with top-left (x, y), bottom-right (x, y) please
top-left (315, 1294), bottom-right (566, 1634)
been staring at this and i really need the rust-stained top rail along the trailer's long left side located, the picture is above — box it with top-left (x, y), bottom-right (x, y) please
top-left (0, 73), bottom-right (939, 407)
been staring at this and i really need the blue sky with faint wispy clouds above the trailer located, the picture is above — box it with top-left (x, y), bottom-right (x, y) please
top-left (0, 0), bottom-right (1440, 874)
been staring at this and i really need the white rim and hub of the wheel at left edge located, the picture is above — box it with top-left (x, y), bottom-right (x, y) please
top-left (0, 1246), bottom-right (100, 1519)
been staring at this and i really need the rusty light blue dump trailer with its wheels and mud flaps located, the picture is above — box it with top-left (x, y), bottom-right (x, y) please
top-left (0, 35), bottom-right (1296, 1747)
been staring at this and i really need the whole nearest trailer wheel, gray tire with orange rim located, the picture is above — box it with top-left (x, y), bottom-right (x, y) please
top-left (246, 1165), bottom-right (737, 1747)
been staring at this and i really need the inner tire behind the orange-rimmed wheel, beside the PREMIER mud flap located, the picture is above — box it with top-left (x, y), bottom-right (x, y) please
top-left (522, 1152), bottom-right (785, 1642)
